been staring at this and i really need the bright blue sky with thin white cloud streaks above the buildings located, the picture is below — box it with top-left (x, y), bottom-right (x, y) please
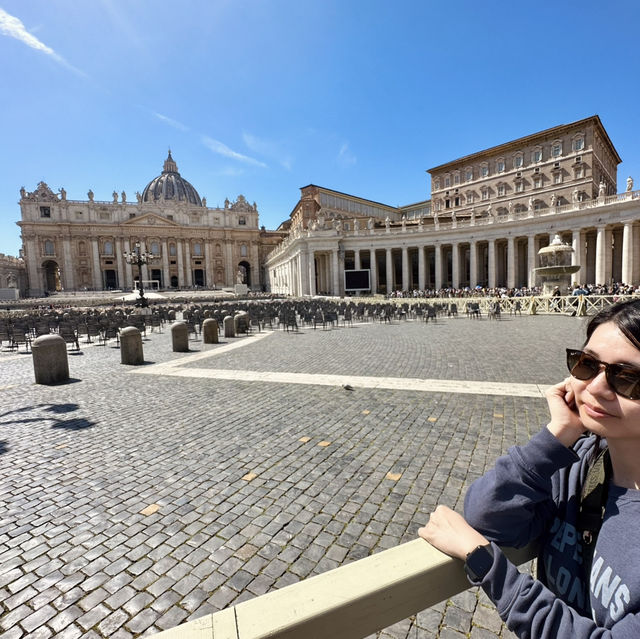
top-left (0, 0), bottom-right (640, 255)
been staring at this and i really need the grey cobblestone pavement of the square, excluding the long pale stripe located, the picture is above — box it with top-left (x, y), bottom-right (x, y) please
top-left (0, 316), bottom-right (584, 639)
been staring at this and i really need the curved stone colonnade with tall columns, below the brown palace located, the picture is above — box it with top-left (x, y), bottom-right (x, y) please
top-left (269, 215), bottom-right (640, 295)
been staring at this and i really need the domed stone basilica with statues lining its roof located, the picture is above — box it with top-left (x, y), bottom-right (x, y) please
top-left (18, 152), bottom-right (286, 297)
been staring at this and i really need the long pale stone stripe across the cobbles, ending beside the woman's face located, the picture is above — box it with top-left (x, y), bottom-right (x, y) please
top-left (131, 362), bottom-right (548, 398)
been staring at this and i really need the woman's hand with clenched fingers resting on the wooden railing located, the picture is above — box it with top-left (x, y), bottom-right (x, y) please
top-left (418, 506), bottom-right (489, 560)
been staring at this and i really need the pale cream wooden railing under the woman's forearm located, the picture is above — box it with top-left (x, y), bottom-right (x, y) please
top-left (155, 539), bottom-right (535, 639)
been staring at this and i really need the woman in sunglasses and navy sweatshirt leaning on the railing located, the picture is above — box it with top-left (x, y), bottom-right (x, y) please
top-left (419, 300), bottom-right (640, 639)
